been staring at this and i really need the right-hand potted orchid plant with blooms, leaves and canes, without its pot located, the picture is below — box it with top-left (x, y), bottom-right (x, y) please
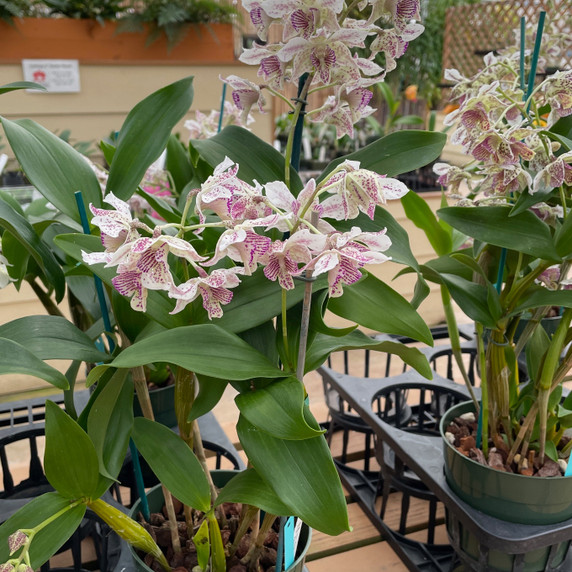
top-left (408, 14), bottom-right (572, 475)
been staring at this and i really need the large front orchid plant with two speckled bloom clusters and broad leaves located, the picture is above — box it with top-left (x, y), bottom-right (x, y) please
top-left (0, 0), bottom-right (445, 572)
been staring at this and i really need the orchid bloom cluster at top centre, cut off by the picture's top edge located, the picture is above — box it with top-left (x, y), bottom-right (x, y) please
top-left (222, 0), bottom-right (424, 138)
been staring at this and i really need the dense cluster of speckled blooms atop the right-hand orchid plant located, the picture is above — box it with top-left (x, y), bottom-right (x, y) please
top-left (435, 21), bottom-right (572, 203)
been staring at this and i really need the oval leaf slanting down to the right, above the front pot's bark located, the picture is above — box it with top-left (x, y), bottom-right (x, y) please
top-left (133, 417), bottom-right (211, 512)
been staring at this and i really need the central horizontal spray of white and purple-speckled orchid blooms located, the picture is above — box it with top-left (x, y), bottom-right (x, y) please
top-left (83, 158), bottom-right (408, 319)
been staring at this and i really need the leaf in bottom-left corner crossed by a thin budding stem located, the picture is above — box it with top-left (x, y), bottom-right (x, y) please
top-left (0, 493), bottom-right (85, 570)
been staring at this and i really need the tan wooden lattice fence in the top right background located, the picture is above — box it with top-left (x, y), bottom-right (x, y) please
top-left (443, 0), bottom-right (572, 76)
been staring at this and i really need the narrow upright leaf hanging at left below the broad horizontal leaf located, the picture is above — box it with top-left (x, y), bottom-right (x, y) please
top-left (87, 370), bottom-right (133, 497)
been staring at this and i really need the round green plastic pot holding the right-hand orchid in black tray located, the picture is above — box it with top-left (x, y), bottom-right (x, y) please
top-left (440, 401), bottom-right (572, 572)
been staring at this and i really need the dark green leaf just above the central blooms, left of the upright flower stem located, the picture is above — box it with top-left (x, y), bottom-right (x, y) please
top-left (191, 125), bottom-right (303, 194)
